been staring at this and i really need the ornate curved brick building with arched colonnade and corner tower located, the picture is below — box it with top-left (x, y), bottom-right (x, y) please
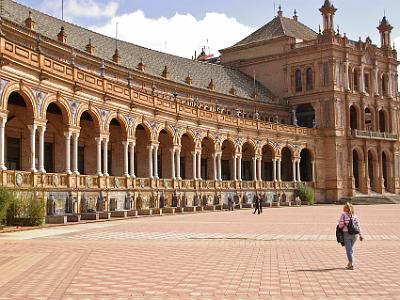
top-left (0, 0), bottom-right (400, 214)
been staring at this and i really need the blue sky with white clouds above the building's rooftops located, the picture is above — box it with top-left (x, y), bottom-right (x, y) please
top-left (14, 0), bottom-right (400, 58)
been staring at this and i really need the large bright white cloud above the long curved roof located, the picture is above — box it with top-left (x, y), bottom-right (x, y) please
top-left (90, 10), bottom-right (255, 58)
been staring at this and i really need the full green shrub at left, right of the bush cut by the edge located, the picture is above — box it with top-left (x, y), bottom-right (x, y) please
top-left (7, 192), bottom-right (46, 226)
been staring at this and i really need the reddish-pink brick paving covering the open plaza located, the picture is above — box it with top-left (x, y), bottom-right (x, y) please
top-left (0, 205), bottom-right (400, 300)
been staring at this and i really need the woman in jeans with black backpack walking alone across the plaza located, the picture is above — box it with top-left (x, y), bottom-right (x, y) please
top-left (339, 203), bottom-right (363, 270)
